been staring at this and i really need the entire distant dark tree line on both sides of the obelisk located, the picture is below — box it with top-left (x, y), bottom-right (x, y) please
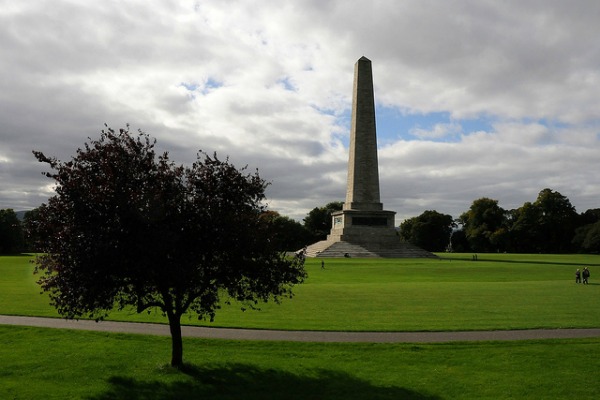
top-left (0, 189), bottom-right (600, 254)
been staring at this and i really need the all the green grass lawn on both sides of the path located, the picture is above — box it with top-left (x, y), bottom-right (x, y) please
top-left (0, 254), bottom-right (600, 400)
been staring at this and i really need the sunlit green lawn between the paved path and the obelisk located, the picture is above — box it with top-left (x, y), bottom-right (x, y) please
top-left (0, 254), bottom-right (600, 331)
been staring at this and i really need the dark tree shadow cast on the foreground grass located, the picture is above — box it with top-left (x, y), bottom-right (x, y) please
top-left (89, 364), bottom-right (441, 400)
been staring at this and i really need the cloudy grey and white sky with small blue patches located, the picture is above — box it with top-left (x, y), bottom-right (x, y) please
top-left (0, 0), bottom-right (600, 225)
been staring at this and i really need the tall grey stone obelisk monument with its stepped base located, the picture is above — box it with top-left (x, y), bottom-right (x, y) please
top-left (306, 57), bottom-right (435, 258)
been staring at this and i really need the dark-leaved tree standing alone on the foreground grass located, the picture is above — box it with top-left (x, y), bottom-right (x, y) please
top-left (28, 127), bottom-right (306, 367)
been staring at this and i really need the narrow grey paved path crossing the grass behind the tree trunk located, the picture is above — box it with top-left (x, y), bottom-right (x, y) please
top-left (0, 315), bottom-right (600, 343)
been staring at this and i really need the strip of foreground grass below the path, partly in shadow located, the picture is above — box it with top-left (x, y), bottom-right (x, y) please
top-left (0, 326), bottom-right (600, 400)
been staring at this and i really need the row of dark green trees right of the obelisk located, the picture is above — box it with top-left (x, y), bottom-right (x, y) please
top-left (400, 189), bottom-right (600, 253)
